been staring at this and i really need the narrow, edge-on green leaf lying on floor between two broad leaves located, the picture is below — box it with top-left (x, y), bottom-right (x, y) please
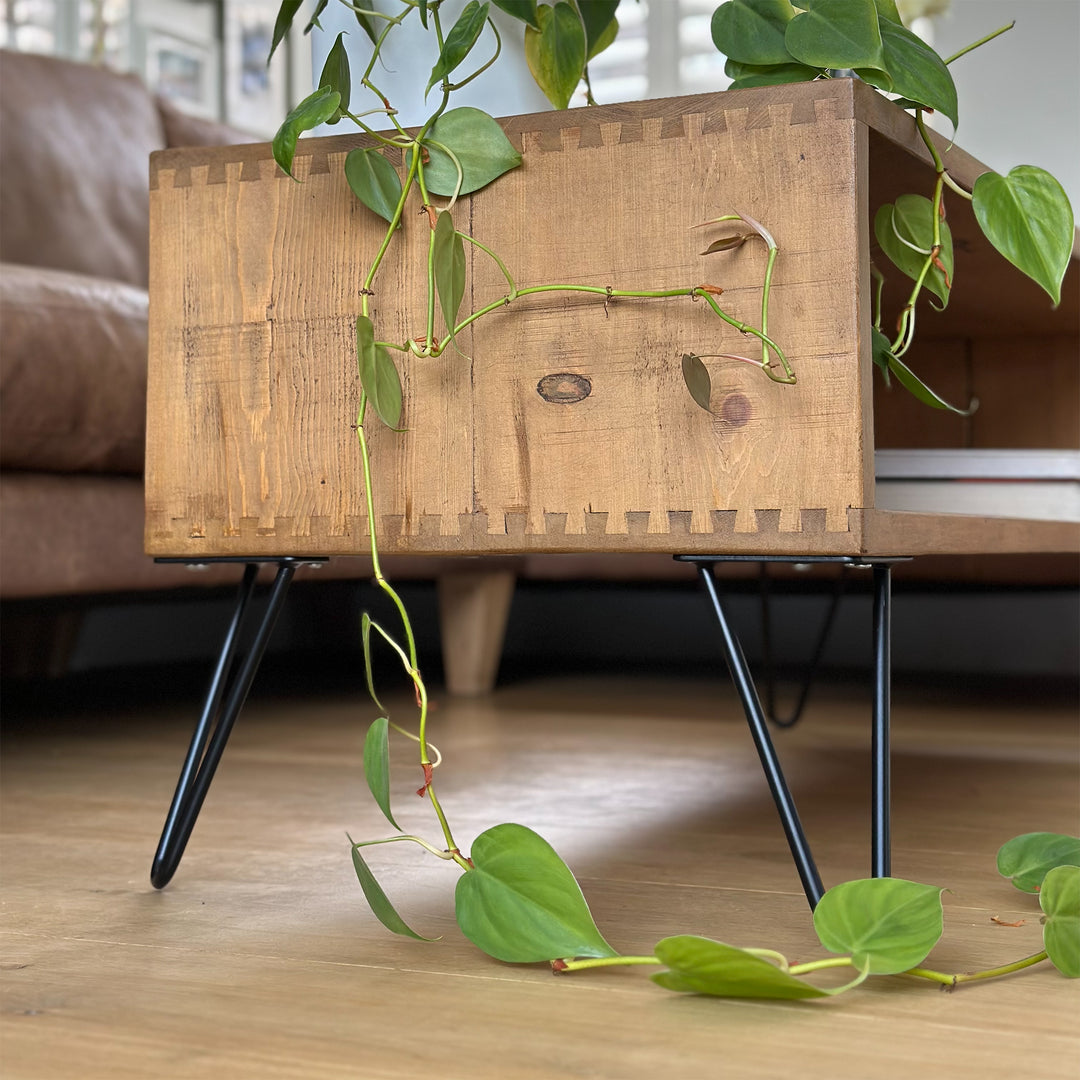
top-left (651, 934), bottom-right (851, 1000)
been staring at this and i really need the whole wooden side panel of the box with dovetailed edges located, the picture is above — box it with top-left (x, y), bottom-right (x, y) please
top-left (147, 84), bottom-right (870, 556)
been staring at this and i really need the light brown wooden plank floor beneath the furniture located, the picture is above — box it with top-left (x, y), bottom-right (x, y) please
top-left (0, 677), bottom-right (1080, 1080)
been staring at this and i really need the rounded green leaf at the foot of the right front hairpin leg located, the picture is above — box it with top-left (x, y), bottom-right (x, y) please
top-left (813, 878), bottom-right (945, 975)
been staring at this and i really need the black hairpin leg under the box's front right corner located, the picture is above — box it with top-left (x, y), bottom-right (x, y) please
top-left (676, 555), bottom-right (897, 907)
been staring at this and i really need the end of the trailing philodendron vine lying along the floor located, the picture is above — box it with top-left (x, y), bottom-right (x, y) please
top-left (365, 820), bottom-right (1080, 999)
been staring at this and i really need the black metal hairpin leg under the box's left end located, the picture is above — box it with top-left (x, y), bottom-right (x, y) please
top-left (150, 557), bottom-right (312, 889)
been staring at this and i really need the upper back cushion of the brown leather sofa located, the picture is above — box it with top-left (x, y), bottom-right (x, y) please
top-left (0, 52), bottom-right (165, 286)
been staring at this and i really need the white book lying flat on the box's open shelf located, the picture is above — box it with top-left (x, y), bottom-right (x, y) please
top-left (875, 449), bottom-right (1080, 524)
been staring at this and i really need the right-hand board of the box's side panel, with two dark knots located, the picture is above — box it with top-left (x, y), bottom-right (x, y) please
top-left (472, 84), bottom-right (865, 549)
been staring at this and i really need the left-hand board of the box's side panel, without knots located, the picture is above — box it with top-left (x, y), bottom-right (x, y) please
top-left (147, 154), bottom-right (472, 555)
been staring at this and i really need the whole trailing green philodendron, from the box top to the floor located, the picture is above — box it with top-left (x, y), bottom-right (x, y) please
top-left (263, 0), bottom-right (1080, 998)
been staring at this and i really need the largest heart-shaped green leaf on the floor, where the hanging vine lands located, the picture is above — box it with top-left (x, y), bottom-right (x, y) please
top-left (455, 825), bottom-right (618, 963)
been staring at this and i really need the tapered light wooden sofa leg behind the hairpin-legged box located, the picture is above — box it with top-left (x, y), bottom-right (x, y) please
top-left (438, 568), bottom-right (516, 697)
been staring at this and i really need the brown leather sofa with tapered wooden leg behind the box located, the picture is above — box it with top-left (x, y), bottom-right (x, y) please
top-left (0, 51), bottom-right (540, 691)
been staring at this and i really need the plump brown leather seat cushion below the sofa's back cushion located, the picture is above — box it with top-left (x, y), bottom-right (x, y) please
top-left (0, 266), bottom-right (148, 475)
